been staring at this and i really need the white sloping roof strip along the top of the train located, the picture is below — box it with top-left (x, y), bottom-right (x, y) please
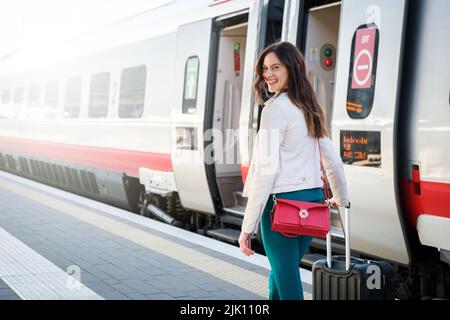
top-left (0, 0), bottom-right (254, 77)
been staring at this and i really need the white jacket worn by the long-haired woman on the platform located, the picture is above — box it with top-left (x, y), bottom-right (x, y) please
top-left (242, 93), bottom-right (348, 233)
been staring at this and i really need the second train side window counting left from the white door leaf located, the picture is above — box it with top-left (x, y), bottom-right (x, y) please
top-left (88, 72), bottom-right (111, 118)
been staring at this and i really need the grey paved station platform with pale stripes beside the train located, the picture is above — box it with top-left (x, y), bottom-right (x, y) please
top-left (0, 172), bottom-right (311, 300)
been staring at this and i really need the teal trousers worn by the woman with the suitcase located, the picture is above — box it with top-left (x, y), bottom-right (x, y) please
top-left (261, 188), bottom-right (324, 300)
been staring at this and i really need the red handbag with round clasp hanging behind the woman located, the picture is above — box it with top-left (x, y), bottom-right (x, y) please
top-left (270, 144), bottom-right (330, 238)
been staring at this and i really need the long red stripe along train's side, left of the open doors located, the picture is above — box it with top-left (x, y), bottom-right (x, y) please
top-left (0, 137), bottom-right (173, 176)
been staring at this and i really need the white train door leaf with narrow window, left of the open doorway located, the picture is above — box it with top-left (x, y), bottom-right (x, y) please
top-left (171, 19), bottom-right (215, 213)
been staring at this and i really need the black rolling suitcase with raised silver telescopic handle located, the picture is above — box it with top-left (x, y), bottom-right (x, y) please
top-left (312, 206), bottom-right (395, 300)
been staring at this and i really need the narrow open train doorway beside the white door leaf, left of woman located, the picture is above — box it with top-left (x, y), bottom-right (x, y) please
top-left (210, 13), bottom-right (248, 225)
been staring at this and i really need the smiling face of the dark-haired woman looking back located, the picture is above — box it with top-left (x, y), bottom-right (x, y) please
top-left (263, 52), bottom-right (289, 93)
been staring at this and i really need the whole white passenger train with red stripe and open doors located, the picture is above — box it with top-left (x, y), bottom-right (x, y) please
top-left (0, 0), bottom-right (450, 299)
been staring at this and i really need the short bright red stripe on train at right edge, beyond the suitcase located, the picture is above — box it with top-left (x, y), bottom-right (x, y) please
top-left (400, 179), bottom-right (450, 227)
